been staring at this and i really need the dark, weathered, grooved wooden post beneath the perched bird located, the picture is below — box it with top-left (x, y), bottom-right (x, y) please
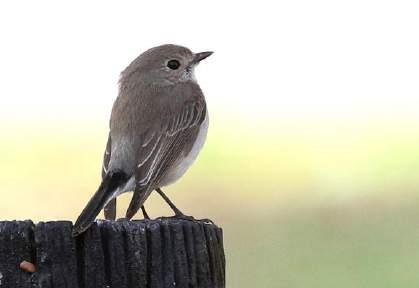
top-left (0, 218), bottom-right (225, 288)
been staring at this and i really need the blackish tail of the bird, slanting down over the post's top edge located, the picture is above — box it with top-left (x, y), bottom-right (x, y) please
top-left (73, 170), bottom-right (128, 237)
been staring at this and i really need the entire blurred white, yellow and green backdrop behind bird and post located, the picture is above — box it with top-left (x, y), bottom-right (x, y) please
top-left (0, 0), bottom-right (419, 288)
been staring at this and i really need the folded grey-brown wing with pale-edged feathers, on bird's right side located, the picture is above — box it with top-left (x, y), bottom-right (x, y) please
top-left (127, 99), bottom-right (206, 218)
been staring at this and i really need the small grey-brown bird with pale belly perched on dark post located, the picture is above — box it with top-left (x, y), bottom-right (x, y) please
top-left (73, 44), bottom-right (213, 236)
